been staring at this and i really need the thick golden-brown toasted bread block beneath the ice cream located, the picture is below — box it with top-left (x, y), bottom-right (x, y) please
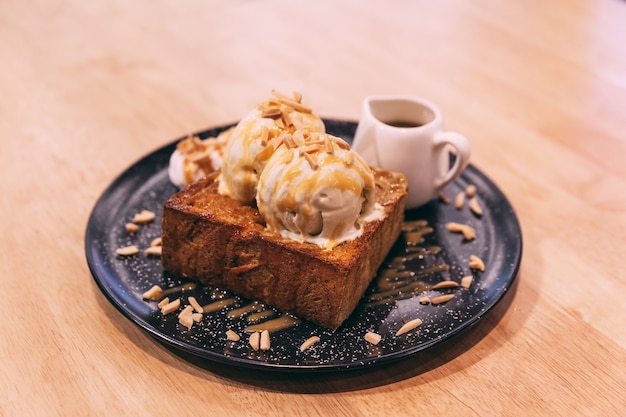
top-left (161, 170), bottom-right (406, 330)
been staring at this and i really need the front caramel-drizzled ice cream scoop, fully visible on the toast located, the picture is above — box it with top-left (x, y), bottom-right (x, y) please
top-left (256, 132), bottom-right (382, 249)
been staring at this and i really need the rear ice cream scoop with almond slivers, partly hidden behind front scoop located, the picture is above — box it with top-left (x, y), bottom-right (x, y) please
top-left (219, 92), bottom-right (325, 204)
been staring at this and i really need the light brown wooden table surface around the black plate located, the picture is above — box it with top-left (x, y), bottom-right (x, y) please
top-left (0, 0), bottom-right (626, 416)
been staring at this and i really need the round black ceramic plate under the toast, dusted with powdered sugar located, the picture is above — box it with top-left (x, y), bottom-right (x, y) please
top-left (85, 120), bottom-right (522, 371)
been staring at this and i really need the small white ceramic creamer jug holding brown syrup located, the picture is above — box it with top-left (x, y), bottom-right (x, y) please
top-left (352, 96), bottom-right (470, 209)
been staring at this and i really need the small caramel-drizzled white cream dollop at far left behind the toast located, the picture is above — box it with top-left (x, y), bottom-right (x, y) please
top-left (167, 129), bottom-right (231, 188)
